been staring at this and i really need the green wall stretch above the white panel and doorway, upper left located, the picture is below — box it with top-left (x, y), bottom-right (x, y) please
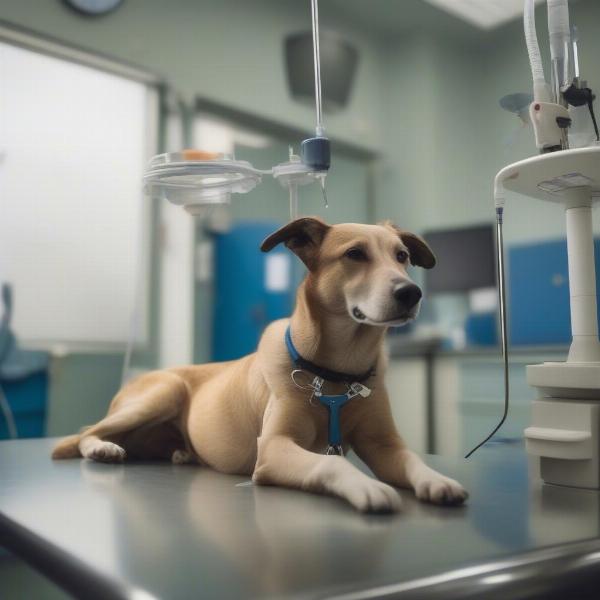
top-left (0, 0), bottom-right (390, 148)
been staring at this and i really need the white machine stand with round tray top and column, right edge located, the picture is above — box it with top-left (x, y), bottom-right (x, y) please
top-left (496, 146), bottom-right (600, 489)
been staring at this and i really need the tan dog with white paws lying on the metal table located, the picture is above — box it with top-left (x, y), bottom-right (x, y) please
top-left (52, 218), bottom-right (467, 511)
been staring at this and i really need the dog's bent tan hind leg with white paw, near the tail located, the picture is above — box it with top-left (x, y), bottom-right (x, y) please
top-left (79, 371), bottom-right (189, 462)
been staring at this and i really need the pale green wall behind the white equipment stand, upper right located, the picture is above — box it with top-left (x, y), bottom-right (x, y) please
top-left (377, 0), bottom-right (600, 244)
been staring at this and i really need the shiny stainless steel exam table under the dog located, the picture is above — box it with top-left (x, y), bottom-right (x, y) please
top-left (0, 440), bottom-right (600, 600)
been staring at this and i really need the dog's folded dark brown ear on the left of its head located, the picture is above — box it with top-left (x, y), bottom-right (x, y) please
top-left (260, 217), bottom-right (330, 271)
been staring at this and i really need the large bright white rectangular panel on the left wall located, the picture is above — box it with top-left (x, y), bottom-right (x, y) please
top-left (0, 43), bottom-right (158, 345)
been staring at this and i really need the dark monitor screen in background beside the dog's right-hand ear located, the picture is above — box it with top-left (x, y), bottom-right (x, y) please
top-left (423, 225), bottom-right (496, 294)
